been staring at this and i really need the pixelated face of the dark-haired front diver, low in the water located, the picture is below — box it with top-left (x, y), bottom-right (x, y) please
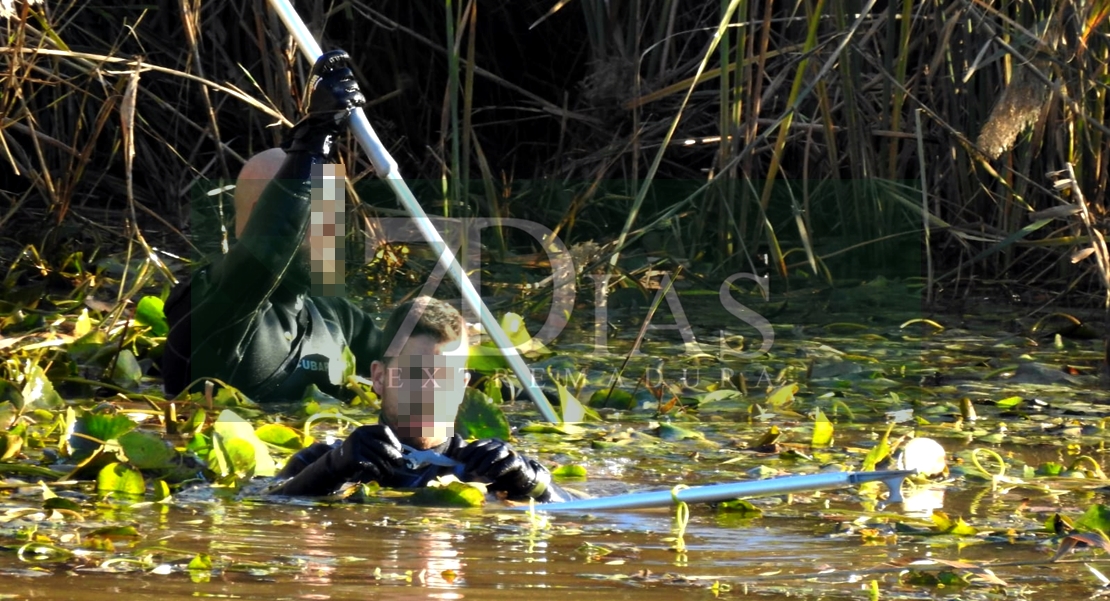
top-left (371, 334), bottom-right (470, 449)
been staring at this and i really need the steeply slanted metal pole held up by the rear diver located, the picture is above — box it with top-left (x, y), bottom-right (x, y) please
top-left (270, 0), bottom-right (559, 423)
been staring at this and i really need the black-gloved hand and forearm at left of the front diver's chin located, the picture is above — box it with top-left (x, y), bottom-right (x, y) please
top-left (271, 424), bottom-right (404, 495)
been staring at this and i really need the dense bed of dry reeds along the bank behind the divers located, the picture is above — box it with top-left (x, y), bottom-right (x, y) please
top-left (0, 0), bottom-right (1110, 307)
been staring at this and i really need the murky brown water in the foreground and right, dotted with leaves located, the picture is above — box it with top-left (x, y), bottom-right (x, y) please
top-left (0, 295), bottom-right (1110, 601)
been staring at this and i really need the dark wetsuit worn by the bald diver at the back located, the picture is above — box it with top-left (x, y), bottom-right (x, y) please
top-left (162, 151), bottom-right (381, 402)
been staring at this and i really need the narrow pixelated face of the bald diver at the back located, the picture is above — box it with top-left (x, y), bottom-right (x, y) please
top-left (307, 164), bottom-right (346, 297)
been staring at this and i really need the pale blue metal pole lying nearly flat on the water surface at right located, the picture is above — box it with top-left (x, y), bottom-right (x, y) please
top-left (513, 470), bottom-right (917, 512)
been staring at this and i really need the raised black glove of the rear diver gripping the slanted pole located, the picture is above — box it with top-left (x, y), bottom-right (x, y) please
top-left (281, 50), bottom-right (366, 157)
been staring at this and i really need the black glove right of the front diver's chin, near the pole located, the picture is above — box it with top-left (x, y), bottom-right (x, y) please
top-left (456, 439), bottom-right (552, 502)
